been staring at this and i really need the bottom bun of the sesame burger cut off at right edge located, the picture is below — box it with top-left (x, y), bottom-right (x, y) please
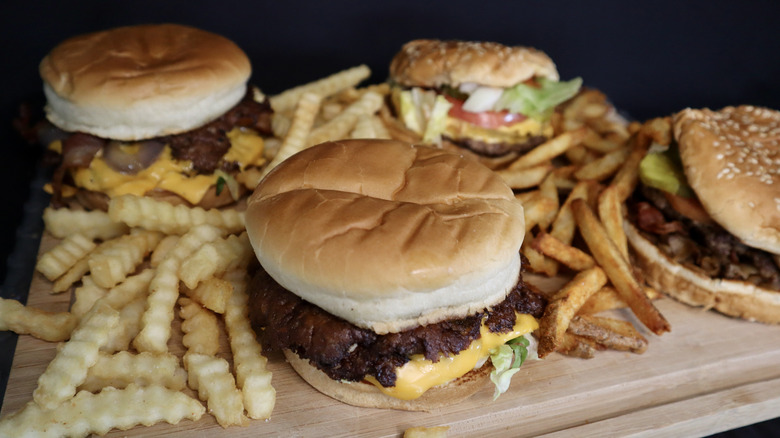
top-left (624, 222), bottom-right (780, 324)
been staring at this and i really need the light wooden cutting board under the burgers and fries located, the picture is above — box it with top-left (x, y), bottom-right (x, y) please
top-left (2, 238), bottom-right (780, 437)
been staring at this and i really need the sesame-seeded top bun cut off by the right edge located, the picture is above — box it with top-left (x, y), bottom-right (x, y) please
top-left (674, 106), bottom-right (780, 254)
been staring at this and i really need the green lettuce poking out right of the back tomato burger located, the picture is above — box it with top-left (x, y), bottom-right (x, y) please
top-left (495, 78), bottom-right (582, 121)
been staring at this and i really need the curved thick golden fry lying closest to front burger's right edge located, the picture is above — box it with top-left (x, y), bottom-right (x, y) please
top-left (539, 266), bottom-right (607, 358)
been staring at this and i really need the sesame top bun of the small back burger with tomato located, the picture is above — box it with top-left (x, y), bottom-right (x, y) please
top-left (390, 40), bottom-right (558, 88)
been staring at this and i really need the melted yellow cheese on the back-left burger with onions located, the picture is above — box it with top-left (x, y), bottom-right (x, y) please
top-left (73, 128), bottom-right (263, 204)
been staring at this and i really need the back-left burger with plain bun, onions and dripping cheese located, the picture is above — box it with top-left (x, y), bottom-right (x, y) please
top-left (38, 24), bottom-right (271, 209)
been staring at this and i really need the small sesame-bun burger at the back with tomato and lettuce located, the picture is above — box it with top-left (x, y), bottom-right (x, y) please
top-left (390, 40), bottom-right (582, 162)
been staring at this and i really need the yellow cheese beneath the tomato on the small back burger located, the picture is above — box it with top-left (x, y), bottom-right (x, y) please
top-left (444, 117), bottom-right (553, 143)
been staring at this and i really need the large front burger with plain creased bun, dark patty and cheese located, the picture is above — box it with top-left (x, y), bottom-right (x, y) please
top-left (246, 140), bottom-right (544, 410)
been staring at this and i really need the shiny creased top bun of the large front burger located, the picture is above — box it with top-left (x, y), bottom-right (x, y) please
top-left (246, 140), bottom-right (525, 334)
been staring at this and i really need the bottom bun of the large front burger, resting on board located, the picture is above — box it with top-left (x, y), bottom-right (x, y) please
top-left (284, 350), bottom-right (492, 411)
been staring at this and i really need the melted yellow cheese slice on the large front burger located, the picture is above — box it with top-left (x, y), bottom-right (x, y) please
top-left (366, 314), bottom-right (539, 400)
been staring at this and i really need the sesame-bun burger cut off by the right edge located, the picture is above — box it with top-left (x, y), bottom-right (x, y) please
top-left (626, 106), bottom-right (780, 323)
